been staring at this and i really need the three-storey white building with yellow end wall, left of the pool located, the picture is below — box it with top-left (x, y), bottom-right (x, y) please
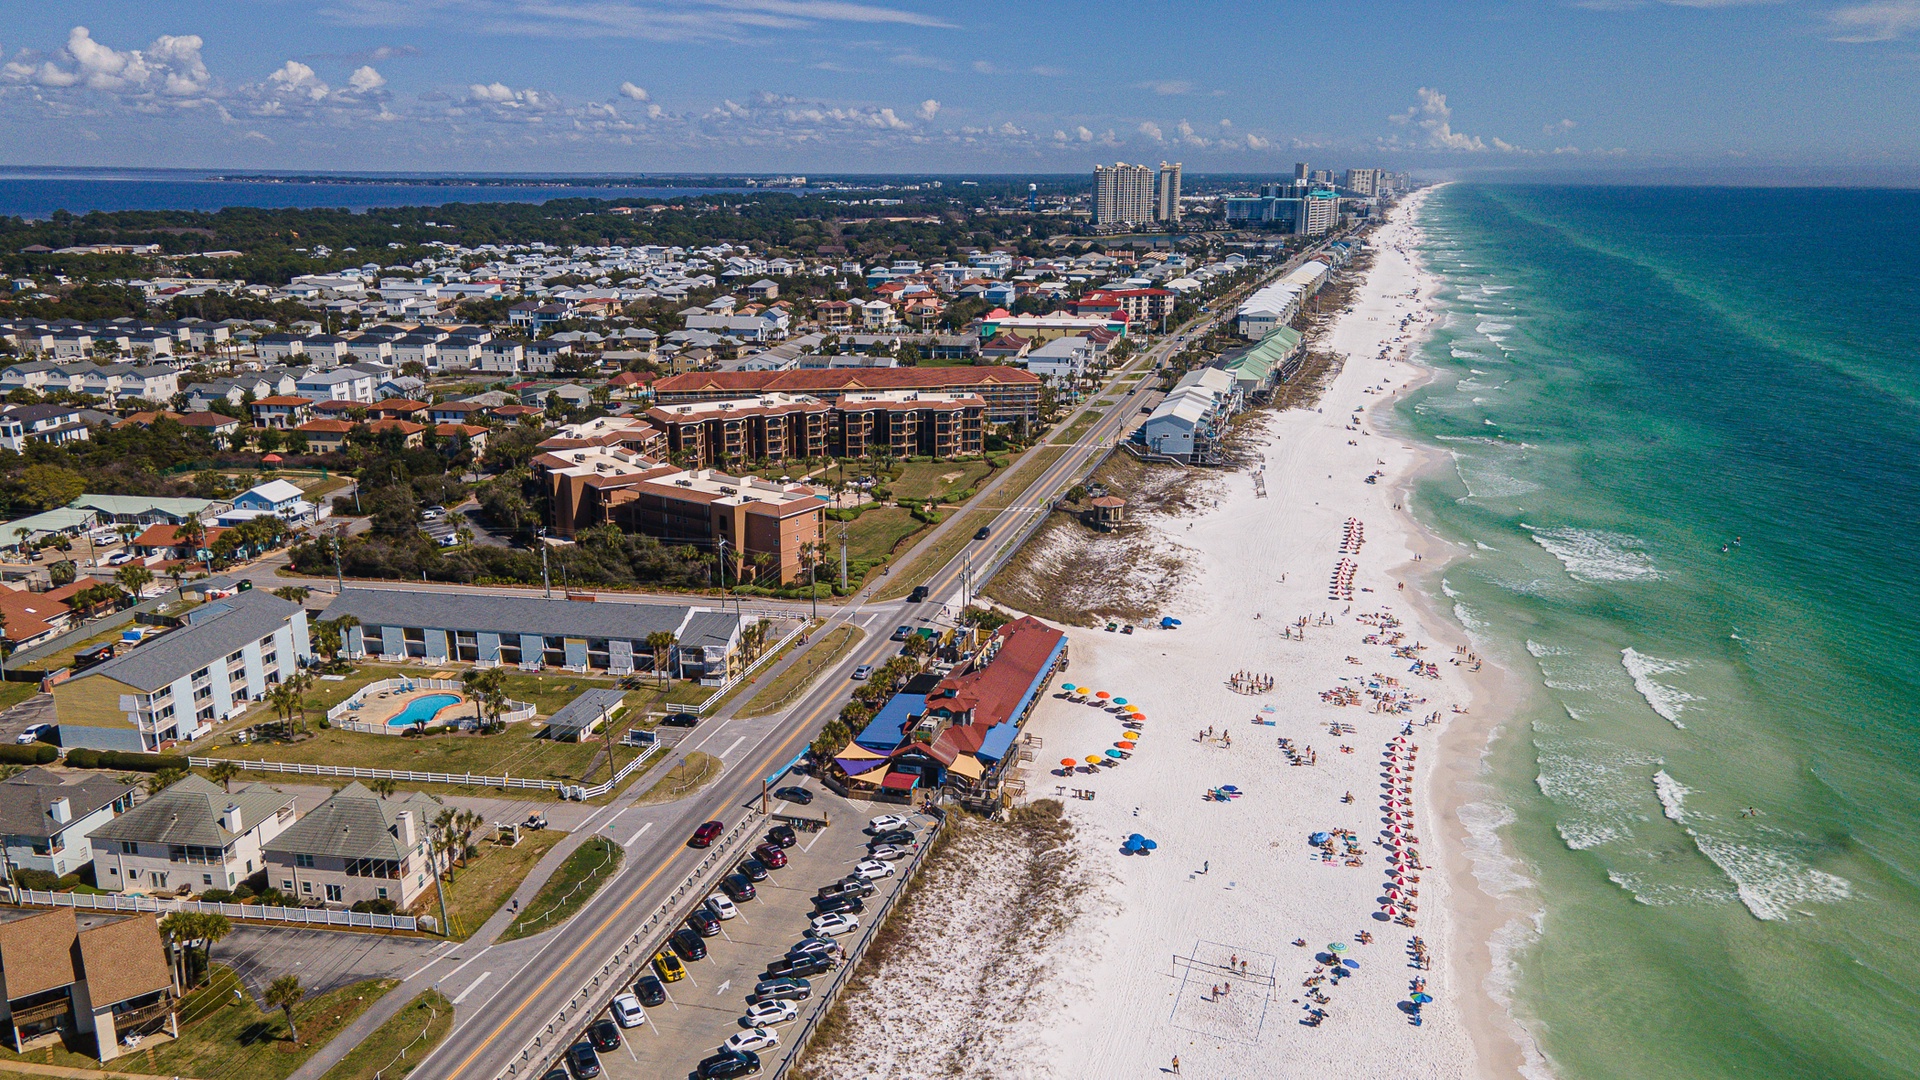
top-left (54, 590), bottom-right (313, 751)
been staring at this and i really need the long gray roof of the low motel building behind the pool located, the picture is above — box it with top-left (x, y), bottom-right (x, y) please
top-left (326, 588), bottom-right (739, 644)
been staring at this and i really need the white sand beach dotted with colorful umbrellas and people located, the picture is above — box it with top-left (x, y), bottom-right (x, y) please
top-left (1027, 194), bottom-right (1517, 1078)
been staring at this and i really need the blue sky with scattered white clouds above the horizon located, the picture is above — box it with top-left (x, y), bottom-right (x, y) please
top-left (0, 0), bottom-right (1920, 173)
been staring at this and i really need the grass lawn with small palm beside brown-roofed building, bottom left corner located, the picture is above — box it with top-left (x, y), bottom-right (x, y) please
top-left (0, 965), bottom-right (399, 1080)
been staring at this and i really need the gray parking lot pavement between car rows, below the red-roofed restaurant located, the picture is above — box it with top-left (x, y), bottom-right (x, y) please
top-left (597, 784), bottom-right (931, 1080)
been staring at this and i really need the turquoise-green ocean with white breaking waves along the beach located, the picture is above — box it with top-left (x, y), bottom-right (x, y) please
top-left (1400, 184), bottom-right (1920, 1080)
